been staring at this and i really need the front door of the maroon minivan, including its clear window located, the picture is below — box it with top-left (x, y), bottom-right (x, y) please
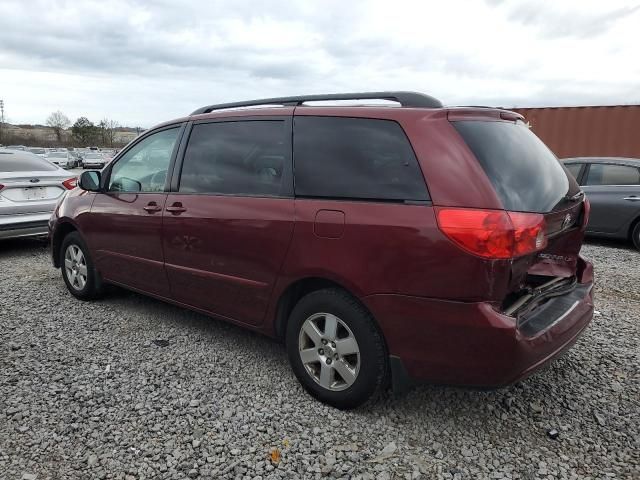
top-left (86, 125), bottom-right (183, 297)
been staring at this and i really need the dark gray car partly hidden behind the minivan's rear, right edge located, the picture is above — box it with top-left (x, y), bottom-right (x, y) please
top-left (563, 157), bottom-right (640, 250)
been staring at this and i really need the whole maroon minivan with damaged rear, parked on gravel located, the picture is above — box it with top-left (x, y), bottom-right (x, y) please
top-left (50, 92), bottom-right (593, 408)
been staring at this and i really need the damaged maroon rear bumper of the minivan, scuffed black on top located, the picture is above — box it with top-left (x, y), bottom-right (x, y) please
top-left (363, 259), bottom-right (594, 391)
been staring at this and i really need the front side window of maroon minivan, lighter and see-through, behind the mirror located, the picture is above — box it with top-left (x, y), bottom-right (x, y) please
top-left (109, 128), bottom-right (180, 192)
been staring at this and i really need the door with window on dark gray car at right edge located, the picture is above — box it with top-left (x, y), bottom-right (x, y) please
top-left (583, 163), bottom-right (640, 238)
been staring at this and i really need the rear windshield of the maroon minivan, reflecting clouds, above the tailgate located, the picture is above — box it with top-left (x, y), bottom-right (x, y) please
top-left (453, 120), bottom-right (569, 213)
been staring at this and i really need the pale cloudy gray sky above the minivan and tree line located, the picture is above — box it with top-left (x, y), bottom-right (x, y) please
top-left (0, 0), bottom-right (640, 127)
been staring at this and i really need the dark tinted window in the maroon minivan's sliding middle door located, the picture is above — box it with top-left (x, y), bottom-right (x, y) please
top-left (179, 120), bottom-right (292, 196)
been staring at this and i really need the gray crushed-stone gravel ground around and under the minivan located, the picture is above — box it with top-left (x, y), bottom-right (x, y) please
top-left (0, 240), bottom-right (640, 480)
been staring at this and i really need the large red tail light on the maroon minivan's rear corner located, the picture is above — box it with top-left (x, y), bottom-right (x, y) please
top-left (437, 208), bottom-right (547, 258)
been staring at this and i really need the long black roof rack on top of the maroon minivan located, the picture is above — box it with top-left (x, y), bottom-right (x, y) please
top-left (191, 92), bottom-right (442, 115)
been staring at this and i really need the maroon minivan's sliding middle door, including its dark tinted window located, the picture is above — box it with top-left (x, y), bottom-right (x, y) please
top-left (163, 116), bottom-right (294, 325)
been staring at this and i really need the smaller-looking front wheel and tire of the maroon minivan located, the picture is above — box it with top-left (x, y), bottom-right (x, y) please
top-left (60, 232), bottom-right (103, 300)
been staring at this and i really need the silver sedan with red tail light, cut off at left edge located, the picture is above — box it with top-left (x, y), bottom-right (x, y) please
top-left (0, 149), bottom-right (76, 239)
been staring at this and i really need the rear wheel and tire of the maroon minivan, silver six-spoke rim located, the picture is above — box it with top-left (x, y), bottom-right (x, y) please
top-left (286, 288), bottom-right (389, 409)
